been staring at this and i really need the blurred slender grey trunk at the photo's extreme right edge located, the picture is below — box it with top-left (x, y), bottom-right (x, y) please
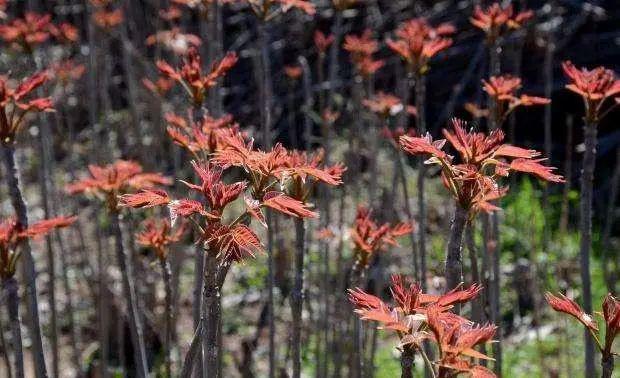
top-left (601, 147), bottom-right (620, 294)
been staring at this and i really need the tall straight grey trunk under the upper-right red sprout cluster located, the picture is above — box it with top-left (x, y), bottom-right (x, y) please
top-left (579, 122), bottom-right (597, 377)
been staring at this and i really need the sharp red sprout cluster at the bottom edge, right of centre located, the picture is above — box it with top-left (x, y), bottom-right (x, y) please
top-left (349, 275), bottom-right (497, 378)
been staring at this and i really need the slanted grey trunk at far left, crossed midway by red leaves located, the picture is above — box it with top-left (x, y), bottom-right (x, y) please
top-left (0, 144), bottom-right (47, 378)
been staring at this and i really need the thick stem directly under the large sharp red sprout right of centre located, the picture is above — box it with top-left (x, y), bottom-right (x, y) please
top-left (446, 204), bottom-right (467, 298)
